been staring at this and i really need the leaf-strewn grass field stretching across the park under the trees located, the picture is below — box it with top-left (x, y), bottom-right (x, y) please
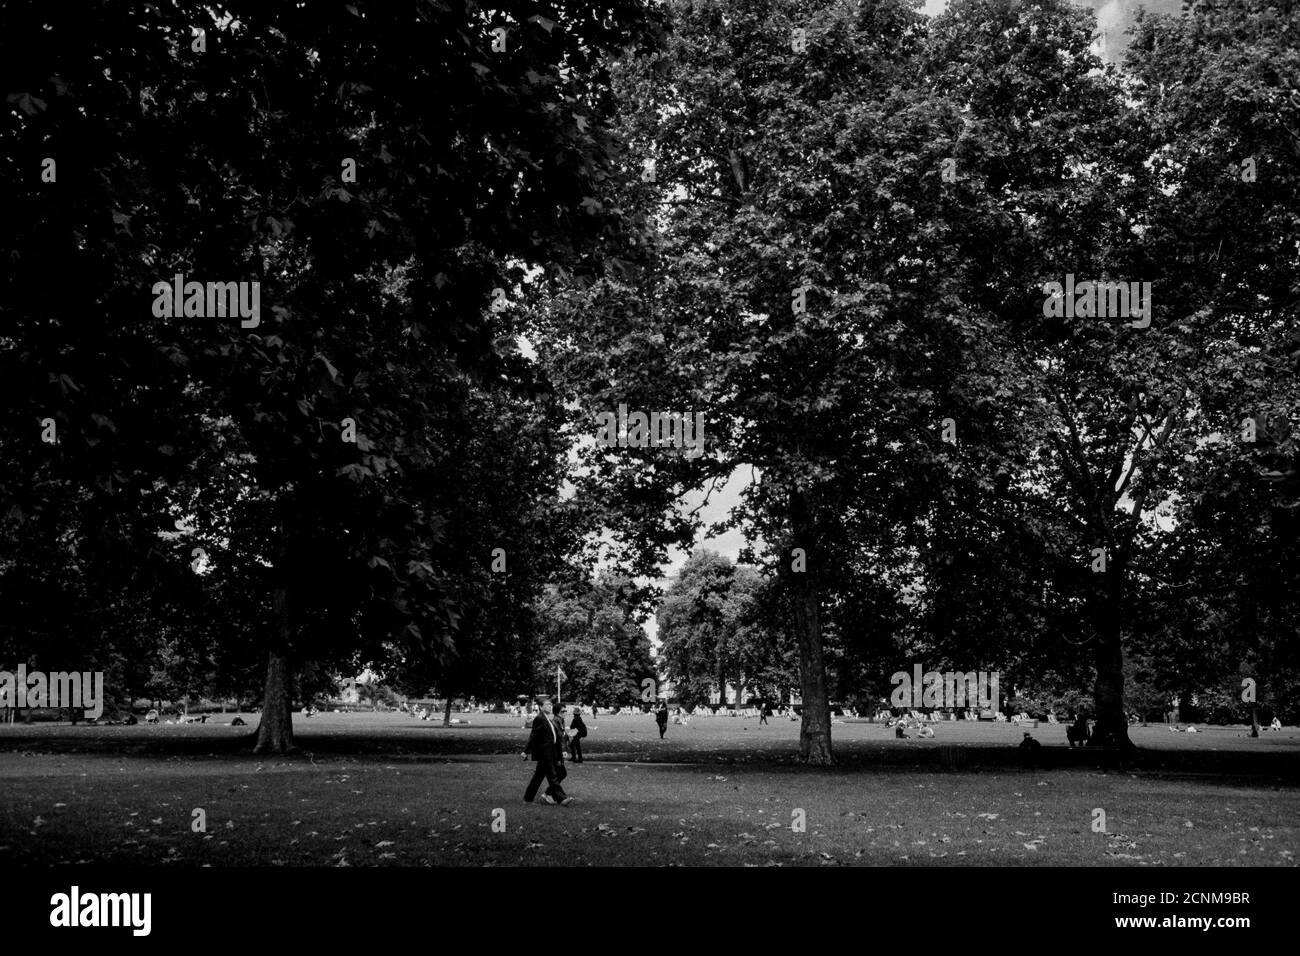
top-left (0, 713), bottom-right (1300, 866)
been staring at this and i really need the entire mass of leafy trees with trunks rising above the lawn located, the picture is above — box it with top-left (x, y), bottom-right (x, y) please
top-left (0, 0), bottom-right (1300, 763)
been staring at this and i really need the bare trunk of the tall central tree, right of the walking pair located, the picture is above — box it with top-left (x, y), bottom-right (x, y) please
top-left (785, 486), bottom-right (835, 766)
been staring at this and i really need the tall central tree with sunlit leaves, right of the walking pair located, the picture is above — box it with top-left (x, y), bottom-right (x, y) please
top-left (543, 1), bottom-right (967, 763)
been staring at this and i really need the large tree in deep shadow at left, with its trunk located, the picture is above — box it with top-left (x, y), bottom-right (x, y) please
top-left (0, 0), bottom-right (660, 750)
